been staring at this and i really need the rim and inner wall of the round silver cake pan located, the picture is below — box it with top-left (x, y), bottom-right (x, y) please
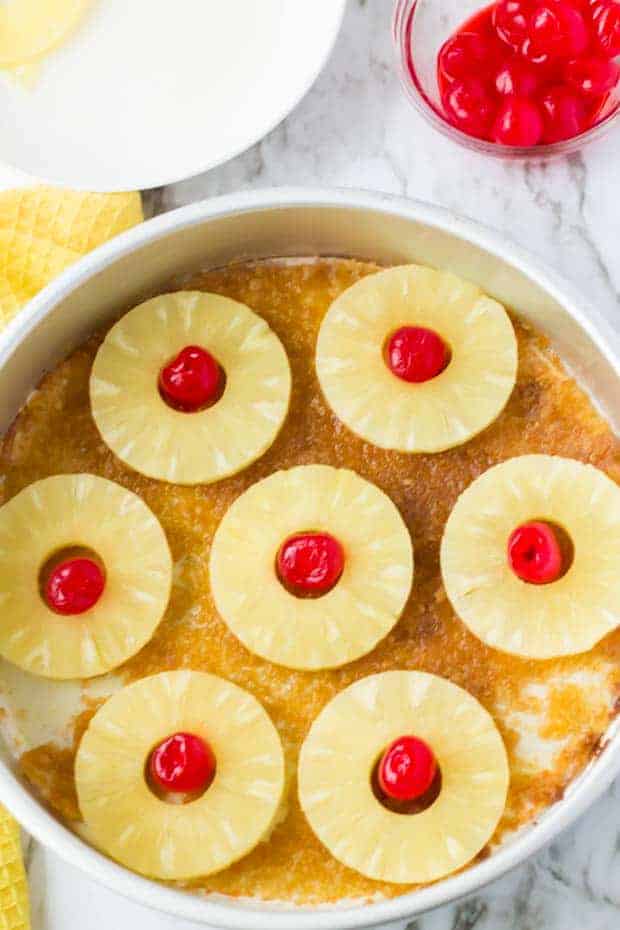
top-left (0, 189), bottom-right (620, 930)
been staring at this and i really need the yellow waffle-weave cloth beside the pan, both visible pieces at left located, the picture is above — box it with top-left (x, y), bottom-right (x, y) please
top-left (0, 187), bottom-right (144, 930)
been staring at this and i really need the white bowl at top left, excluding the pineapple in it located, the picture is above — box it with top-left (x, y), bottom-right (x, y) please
top-left (0, 0), bottom-right (346, 191)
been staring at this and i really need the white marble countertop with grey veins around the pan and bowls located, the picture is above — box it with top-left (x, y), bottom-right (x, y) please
top-left (21, 0), bottom-right (620, 930)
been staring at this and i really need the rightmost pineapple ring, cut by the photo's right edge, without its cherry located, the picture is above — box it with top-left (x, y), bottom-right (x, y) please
top-left (441, 455), bottom-right (620, 659)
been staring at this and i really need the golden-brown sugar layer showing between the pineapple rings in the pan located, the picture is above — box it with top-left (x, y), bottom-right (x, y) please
top-left (0, 259), bottom-right (620, 903)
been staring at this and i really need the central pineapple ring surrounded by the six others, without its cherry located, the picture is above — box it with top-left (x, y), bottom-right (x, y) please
top-left (209, 465), bottom-right (413, 669)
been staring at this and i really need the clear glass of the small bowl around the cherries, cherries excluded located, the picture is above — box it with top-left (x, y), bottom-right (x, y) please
top-left (392, 0), bottom-right (620, 159)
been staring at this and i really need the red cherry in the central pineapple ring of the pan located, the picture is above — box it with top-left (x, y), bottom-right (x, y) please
top-left (276, 533), bottom-right (344, 597)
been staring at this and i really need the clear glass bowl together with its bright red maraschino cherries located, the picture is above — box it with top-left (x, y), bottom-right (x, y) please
top-left (394, 0), bottom-right (620, 158)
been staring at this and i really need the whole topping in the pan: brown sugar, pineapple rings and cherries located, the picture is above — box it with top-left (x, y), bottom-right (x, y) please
top-left (0, 259), bottom-right (620, 904)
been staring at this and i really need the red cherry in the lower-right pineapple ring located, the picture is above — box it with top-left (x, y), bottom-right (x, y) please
top-left (378, 736), bottom-right (437, 801)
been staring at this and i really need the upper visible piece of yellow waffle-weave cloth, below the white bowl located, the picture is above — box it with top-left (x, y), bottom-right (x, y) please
top-left (0, 186), bottom-right (144, 328)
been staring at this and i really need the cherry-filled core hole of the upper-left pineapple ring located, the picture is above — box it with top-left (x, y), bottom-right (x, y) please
top-left (157, 345), bottom-right (227, 413)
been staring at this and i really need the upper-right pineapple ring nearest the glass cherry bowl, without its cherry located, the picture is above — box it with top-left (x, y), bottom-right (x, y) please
top-left (316, 265), bottom-right (517, 452)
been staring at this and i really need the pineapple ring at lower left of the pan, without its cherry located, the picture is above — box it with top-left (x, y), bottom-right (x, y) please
top-left (75, 670), bottom-right (284, 879)
